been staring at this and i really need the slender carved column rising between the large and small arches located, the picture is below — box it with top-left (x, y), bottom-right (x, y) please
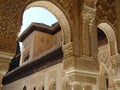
top-left (82, 6), bottom-right (97, 57)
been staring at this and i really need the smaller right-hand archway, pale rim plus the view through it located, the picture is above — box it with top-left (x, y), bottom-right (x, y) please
top-left (97, 23), bottom-right (117, 90)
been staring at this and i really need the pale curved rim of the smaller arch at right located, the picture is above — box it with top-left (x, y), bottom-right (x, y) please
top-left (98, 22), bottom-right (118, 56)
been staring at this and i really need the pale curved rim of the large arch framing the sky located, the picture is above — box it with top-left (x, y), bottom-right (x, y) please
top-left (21, 0), bottom-right (71, 44)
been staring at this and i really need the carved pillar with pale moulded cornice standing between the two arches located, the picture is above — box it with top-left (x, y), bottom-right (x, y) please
top-left (62, 3), bottom-right (99, 90)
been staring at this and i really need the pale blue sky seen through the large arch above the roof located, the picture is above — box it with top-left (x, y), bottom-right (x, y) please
top-left (20, 7), bottom-right (57, 34)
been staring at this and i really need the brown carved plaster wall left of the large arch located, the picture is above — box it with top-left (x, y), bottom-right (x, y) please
top-left (0, 0), bottom-right (20, 53)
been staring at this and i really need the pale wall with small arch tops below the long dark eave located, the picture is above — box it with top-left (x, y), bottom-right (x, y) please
top-left (3, 63), bottom-right (64, 90)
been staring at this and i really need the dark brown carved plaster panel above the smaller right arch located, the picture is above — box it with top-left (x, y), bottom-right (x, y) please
top-left (96, 0), bottom-right (116, 25)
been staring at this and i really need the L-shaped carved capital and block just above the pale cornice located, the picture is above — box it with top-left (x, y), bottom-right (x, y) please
top-left (62, 42), bottom-right (98, 72)
